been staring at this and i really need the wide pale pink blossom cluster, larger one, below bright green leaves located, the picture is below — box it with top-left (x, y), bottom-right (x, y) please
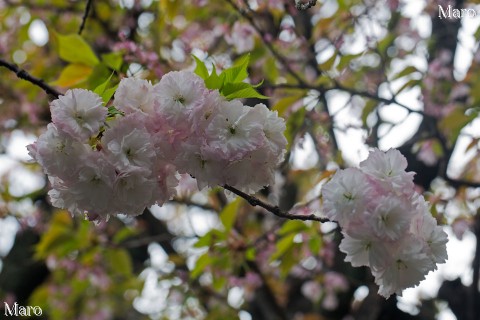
top-left (28, 71), bottom-right (287, 219)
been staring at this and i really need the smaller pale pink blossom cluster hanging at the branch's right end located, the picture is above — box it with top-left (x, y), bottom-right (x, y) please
top-left (322, 149), bottom-right (448, 297)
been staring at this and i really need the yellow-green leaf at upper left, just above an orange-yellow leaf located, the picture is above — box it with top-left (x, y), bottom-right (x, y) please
top-left (56, 33), bottom-right (100, 67)
